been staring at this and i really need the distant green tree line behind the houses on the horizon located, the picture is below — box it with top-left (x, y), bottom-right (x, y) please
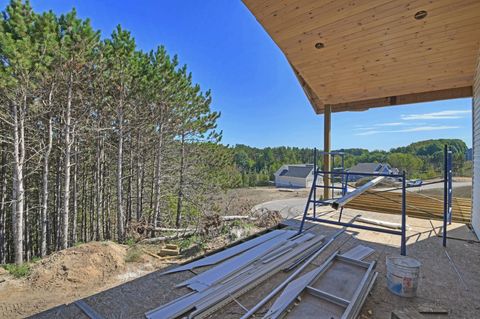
top-left (233, 139), bottom-right (471, 186)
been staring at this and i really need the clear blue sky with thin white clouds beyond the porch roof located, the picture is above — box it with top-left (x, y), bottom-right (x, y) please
top-left (7, 0), bottom-right (472, 149)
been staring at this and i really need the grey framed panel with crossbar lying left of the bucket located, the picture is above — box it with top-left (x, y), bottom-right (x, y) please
top-left (264, 245), bottom-right (377, 319)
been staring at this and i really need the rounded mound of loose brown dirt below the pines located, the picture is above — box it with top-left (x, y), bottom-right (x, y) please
top-left (29, 242), bottom-right (127, 288)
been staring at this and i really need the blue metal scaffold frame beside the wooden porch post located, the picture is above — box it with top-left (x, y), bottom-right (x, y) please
top-left (299, 149), bottom-right (406, 256)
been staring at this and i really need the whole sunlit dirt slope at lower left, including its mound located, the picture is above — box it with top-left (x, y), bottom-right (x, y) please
top-left (0, 242), bottom-right (162, 319)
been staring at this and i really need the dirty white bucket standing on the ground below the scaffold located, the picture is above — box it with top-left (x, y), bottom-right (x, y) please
top-left (387, 256), bottom-right (422, 297)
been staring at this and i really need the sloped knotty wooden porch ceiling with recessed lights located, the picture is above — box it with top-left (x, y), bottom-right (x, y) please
top-left (243, 0), bottom-right (480, 113)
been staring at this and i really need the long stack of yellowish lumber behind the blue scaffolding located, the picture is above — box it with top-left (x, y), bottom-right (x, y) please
top-left (345, 191), bottom-right (472, 224)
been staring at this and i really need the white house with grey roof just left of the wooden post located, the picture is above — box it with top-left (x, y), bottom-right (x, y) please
top-left (275, 164), bottom-right (313, 188)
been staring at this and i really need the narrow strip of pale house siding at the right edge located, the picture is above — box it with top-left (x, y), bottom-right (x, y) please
top-left (472, 54), bottom-right (480, 238)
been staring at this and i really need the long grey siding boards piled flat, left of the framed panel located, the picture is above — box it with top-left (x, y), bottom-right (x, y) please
top-left (145, 230), bottom-right (324, 319)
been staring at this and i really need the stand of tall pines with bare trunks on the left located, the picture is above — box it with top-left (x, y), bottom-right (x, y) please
top-left (0, 0), bottom-right (236, 264)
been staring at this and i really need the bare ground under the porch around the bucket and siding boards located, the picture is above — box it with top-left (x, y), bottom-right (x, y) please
top-left (27, 210), bottom-right (480, 319)
